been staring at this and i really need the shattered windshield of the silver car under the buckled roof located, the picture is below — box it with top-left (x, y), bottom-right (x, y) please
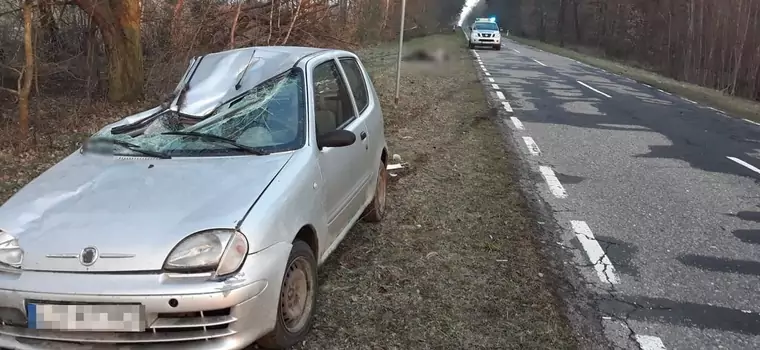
top-left (87, 69), bottom-right (305, 156)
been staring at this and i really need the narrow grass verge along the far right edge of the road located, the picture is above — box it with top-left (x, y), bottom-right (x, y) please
top-left (509, 36), bottom-right (760, 121)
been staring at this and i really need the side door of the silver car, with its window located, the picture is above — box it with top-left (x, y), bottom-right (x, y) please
top-left (312, 58), bottom-right (369, 241)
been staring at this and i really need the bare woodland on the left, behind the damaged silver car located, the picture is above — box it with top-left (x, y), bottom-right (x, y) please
top-left (0, 0), bottom-right (463, 139)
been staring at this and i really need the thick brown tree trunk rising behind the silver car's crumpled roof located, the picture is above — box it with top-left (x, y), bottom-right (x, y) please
top-left (75, 0), bottom-right (144, 102)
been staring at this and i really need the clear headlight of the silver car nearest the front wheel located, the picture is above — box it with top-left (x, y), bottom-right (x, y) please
top-left (164, 230), bottom-right (248, 276)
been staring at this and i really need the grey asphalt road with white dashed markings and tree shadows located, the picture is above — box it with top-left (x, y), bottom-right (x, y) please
top-left (473, 33), bottom-right (760, 350)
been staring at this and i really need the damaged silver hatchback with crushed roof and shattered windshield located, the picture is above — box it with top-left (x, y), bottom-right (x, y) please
top-left (0, 47), bottom-right (388, 350)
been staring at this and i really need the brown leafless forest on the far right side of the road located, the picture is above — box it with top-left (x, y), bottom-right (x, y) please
top-left (485, 0), bottom-right (760, 101)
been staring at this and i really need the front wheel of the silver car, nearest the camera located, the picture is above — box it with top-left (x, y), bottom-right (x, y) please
top-left (256, 240), bottom-right (317, 350)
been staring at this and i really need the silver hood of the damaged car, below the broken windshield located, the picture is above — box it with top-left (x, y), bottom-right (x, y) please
top-left (0, 152), bottom-right (292, 272)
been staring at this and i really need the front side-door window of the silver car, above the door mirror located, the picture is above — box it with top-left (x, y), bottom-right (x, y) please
top-left (314, 60), bottom-right (354, 135)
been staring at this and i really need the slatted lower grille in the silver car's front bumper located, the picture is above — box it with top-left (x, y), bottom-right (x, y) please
top-left (0, 308), bottom-right (237, 344)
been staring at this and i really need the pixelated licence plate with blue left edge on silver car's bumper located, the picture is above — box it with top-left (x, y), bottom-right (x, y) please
top-left (26, 303), bottom-right (145, 332)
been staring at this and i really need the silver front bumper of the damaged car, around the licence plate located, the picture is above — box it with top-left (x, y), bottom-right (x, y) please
top-left (0, 243), bottom-right (291, 350)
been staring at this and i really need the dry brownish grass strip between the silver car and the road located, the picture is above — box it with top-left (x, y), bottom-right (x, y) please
top-left (292, 35), bottom-right (577, 349)
